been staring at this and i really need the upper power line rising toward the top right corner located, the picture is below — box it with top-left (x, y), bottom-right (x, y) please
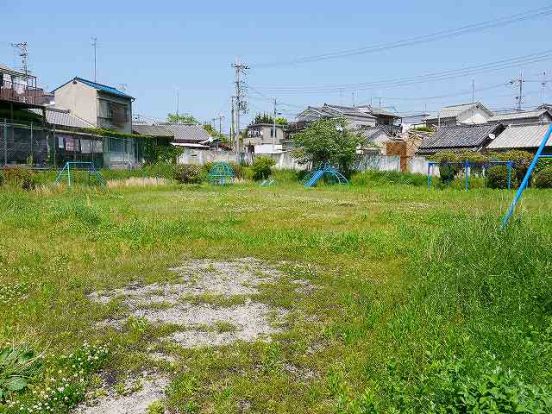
top-left (253, 6), bottom-right (552, 69)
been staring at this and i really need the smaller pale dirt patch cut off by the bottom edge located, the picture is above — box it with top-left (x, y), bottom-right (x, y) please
top-left (73, 374), bottom-right (169, 414)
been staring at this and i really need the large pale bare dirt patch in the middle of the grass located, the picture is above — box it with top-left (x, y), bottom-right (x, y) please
top-left (89, 258), bottom-right (288, 348)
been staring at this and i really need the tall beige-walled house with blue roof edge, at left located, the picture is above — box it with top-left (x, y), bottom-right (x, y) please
top-left (54, 77), bottom-right (134, 134)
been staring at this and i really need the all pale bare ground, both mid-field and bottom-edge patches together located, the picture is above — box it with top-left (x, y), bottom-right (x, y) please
top-left (75, 258), bottom-right (306, 414)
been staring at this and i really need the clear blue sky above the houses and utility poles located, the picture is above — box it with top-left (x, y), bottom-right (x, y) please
top-left (0, 0), bottom-right (552, 128)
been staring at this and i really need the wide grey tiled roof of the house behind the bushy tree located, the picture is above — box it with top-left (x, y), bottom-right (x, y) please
top-left (297, 104), bottom-right (377, 129)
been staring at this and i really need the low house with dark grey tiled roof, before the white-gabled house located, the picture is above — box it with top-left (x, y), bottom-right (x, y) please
top-left (417, 124), bottom-right (504, 155)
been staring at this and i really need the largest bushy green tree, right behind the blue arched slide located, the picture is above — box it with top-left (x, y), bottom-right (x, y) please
top-left (293, 119), bottom-right (365, 174)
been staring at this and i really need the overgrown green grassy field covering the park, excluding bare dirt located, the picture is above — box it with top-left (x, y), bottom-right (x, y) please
top-left (0, 177), bottom-right (552, 413)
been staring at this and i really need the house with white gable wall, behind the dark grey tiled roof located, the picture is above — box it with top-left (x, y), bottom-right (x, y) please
top-left (426, 102), bottom-right (494, 127)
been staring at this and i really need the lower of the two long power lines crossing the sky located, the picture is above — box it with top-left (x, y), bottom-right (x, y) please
top-left (255, 49), bottom-right (552, 94)
